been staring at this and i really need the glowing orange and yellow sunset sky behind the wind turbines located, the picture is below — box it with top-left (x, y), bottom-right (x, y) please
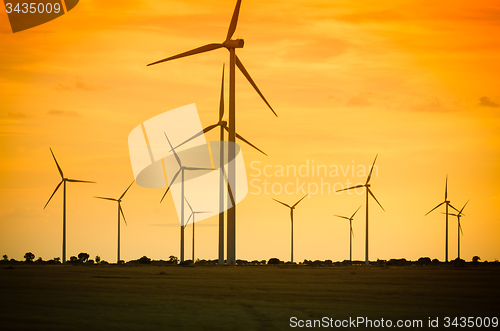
top-left (0, 0), bottom-right (500, 262)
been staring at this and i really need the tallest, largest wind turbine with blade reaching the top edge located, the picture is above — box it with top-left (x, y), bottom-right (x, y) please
top-left (148, 0), bottom-right (278, 264)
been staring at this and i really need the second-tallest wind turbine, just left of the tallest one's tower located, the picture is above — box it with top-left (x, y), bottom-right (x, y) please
top-left (175, 66), bottom-right (267, 265)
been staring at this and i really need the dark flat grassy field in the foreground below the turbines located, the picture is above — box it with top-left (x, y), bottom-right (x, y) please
top-left (0, 265), bottom-right (500, 330)
